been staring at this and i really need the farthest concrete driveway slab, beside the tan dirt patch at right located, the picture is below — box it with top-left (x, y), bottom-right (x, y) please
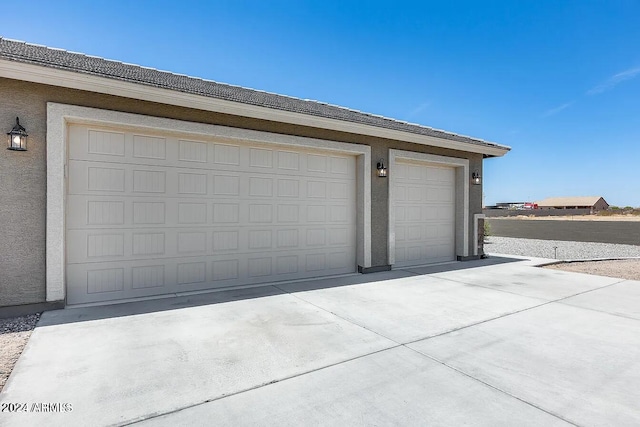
top-left (428, 263), bottom-right (621, 301)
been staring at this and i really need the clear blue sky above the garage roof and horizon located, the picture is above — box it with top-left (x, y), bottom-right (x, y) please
top-left (5, 0), bottom-right (640, 206)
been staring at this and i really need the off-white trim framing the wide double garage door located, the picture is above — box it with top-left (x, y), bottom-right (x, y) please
top-left (46, 103), bottom-right (371, 301)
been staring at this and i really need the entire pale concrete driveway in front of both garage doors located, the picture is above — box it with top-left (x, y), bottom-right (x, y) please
top-left (0, 258), bottom-right (640, 426)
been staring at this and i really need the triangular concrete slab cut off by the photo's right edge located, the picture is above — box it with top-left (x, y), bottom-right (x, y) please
top-left (562, 280), bottom-right (640, 320)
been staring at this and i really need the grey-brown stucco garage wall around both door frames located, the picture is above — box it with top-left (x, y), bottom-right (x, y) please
top-left (0, 79), bottom-right (482, 306)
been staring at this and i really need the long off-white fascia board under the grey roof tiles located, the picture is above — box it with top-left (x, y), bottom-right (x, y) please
top-left (0, 60), bottom-right (510, 157)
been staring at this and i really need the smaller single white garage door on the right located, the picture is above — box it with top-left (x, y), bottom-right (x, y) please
top-left (392, 161), bottom-right (455, 267)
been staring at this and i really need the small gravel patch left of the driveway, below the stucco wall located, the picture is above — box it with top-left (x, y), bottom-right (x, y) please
top-left (0, 313), bottom-right (40, 391)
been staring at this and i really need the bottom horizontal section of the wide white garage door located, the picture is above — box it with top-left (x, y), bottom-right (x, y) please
top-left (67, 250), bottom-right (355, 304)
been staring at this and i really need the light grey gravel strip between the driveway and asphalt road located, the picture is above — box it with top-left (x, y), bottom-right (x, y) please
top-left (484, 236), bottom-right (640, 260)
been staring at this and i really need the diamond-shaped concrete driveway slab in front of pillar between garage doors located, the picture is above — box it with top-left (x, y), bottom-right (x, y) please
top-left (279, 270), bottom-right (545, 343)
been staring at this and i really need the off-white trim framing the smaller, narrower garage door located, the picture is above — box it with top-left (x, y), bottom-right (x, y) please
top-left (388, 149), bottom-right (469, 265)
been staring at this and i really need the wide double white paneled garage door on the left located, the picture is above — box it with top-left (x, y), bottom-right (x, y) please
top-left (66, 125), bottom-right (356, 304)
